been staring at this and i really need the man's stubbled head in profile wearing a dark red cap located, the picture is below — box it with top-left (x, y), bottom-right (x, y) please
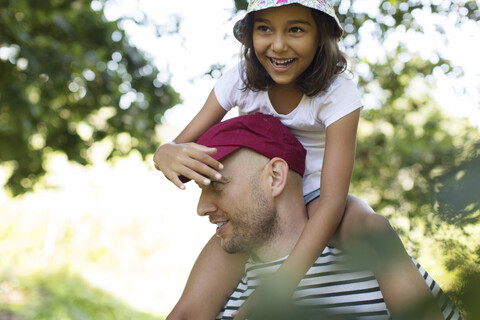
top-left (197, 114), bottom-right (306, 260)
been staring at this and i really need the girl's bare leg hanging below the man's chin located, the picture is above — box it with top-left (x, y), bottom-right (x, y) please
top-left (167, 236), bottom-right (247, 320)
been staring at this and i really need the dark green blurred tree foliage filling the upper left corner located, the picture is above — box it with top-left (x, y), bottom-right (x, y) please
top-left (0, 0), bottom-right (179, 195)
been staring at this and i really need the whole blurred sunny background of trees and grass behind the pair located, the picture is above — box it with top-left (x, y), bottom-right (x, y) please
top-left (0, 0), bottom-right (480, 320)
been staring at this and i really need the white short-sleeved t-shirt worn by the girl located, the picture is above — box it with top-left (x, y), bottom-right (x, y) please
top-left (215, 64), bottom-right (362, 195)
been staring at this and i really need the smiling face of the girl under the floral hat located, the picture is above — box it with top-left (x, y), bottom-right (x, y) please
top-left (253, 4), bottom-right (318, 85)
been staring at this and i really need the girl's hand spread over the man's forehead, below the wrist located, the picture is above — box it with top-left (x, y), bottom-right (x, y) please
top-left (153, 142), bottom-right (223, 190)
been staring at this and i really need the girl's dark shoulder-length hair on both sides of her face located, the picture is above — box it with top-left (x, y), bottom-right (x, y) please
top-left (243, 9), bottom-right (347, 96)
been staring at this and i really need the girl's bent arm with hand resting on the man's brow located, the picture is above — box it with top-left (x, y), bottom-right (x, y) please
top-left (153, 90), bottom-right (226, 189)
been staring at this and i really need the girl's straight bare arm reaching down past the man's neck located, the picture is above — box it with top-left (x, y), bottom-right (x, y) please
top-left (278, 109), bottom-right (360, 282)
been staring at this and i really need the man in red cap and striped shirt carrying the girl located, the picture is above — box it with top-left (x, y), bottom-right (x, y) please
top-left (174, 114), bottom-right (461, 319)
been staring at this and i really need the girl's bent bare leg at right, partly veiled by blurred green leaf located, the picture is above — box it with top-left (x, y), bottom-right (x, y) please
top-left (309, 195), bottom-right (444, 320)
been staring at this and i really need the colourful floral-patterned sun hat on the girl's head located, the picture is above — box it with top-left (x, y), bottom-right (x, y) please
top-left (233, 0), bottom-right (343, 42)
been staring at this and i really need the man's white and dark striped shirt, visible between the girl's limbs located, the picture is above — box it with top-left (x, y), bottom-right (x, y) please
top-left (217, 247), bottom-right (462, 320)
